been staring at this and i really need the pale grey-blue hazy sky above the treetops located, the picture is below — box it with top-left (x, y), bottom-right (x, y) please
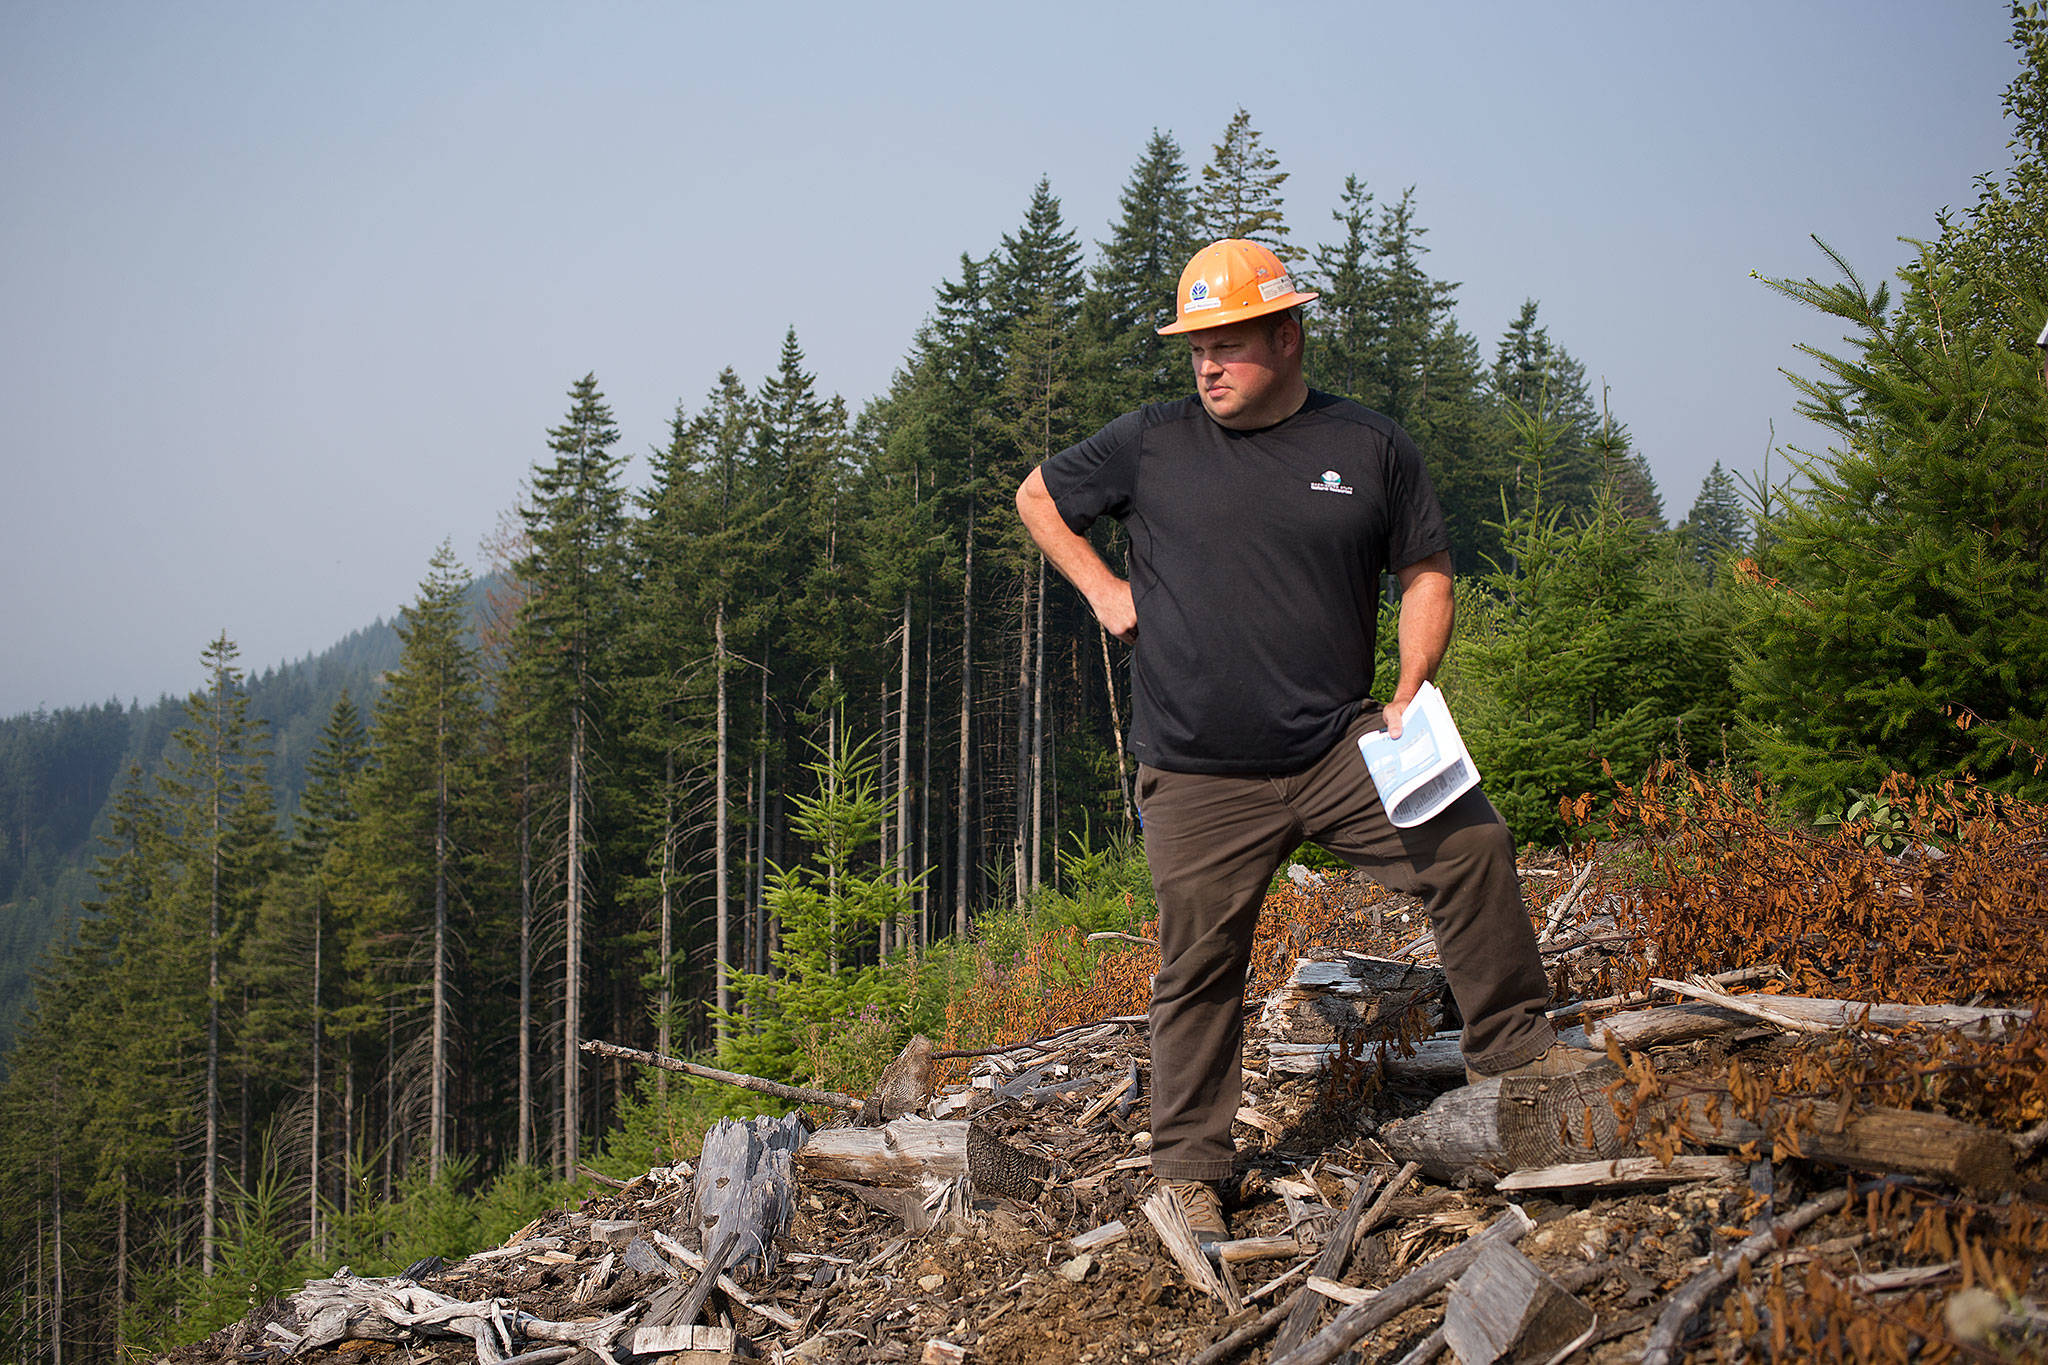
top-left (0, 0), bottom-right (2017, 714)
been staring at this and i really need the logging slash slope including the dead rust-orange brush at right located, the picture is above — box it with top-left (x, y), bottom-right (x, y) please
top-left (172, 782), bottom-right (2048, 1365)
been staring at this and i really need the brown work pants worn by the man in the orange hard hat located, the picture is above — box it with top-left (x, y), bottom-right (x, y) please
top-left (1139, 702), bottom-right (1556, 1181)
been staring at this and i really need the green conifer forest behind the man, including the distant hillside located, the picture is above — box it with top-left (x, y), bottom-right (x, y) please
top-left (0, 12), bottom-right (2048, 1363)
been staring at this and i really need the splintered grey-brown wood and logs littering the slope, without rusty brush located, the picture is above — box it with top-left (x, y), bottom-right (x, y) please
top-left (170, 862), bottom-right (2048, 1365)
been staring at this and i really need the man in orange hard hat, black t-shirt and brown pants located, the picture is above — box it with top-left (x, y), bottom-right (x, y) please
top-left (1018, 239), bottom-right (1597, 1240)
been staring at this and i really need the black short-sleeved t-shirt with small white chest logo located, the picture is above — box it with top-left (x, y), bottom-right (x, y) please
top-left (1042, 393), bottom-right (1450, 774)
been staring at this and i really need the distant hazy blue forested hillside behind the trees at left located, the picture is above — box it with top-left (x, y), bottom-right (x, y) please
top-left (0, 620), bottom-right (399, 1056)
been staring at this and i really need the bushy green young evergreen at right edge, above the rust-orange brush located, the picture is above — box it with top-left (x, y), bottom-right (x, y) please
top-left (1739, 248), bottom-right (2048, 806)
